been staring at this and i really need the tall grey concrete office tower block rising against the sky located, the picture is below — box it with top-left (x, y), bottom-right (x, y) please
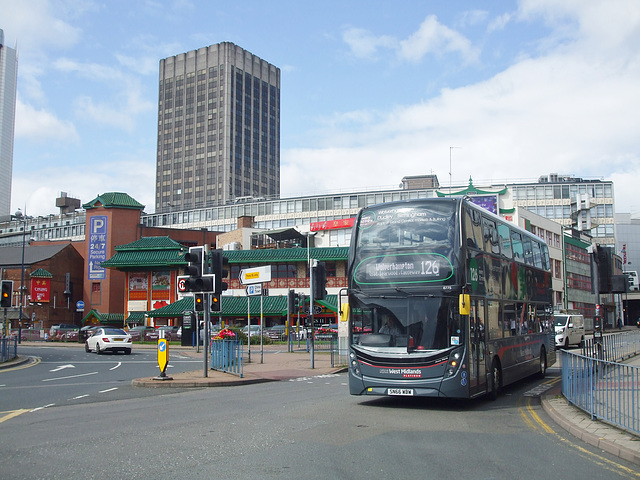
top-left (155, 42), bottom-right (280, 213)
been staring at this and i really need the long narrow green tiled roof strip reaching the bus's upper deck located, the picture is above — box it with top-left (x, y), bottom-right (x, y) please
top-left (224, 247), bottom-right (349, 263)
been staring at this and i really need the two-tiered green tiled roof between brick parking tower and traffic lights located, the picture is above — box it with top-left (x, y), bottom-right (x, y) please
top-left (101, 237), bottom-right (186, 270)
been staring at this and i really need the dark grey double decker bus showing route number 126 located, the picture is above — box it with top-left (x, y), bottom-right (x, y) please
top-left (341, 197), bottom-right (555, 398)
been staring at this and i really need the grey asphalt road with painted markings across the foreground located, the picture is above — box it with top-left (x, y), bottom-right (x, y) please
top-left (0, 344), bottom-right (640, 480)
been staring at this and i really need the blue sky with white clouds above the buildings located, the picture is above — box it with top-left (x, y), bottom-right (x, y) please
top-left (0, 0), bottom-right (640, 217)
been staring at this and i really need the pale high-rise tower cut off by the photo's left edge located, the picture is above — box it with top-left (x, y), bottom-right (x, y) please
top-left (0, 29), bottom-right (18, 216)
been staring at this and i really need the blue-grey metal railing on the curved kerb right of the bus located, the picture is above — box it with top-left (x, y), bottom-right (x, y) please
top-left (561, 332), bottom-right (640, 436)
